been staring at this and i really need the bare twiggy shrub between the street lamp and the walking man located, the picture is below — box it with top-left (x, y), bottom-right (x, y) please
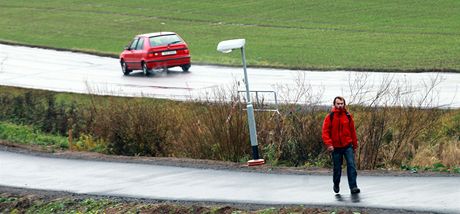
top-left (274, 72), bottom-right (328, 166)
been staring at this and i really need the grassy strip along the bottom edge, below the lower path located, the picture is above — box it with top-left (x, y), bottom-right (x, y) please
top-left (0, 193), bottom-right (370, 214)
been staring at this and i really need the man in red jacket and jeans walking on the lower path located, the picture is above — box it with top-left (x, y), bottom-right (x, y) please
top-left (322, 97), bottom-right (360, 194)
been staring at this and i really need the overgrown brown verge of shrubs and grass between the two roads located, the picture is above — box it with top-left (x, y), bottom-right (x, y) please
top-left (0, 87), bottom-right (460, 172)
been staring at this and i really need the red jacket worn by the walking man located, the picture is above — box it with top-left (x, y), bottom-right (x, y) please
top-left (323, 107), bottom-right (358, 150)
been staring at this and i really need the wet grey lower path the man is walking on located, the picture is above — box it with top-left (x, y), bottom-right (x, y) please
top-left (0, 151), bottom-right (460, 213)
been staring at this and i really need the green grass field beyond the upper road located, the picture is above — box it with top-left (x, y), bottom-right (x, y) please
top-left (0, 0), bottom-right (460, 72)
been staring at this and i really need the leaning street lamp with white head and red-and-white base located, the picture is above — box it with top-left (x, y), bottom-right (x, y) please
top-left (217, 39), bottom-right (265, 166)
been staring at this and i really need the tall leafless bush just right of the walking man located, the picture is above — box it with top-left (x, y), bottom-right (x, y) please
top-left (350, 72), bottom-right (452, 169)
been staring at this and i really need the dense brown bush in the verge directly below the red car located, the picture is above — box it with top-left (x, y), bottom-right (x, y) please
top-left (92, 98), bottom-right (171, 156)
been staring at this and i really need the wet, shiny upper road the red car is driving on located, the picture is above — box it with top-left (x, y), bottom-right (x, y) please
top-left (0, 44), bottom-right (460, 108)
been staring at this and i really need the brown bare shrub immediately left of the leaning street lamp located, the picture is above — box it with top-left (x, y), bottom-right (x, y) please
top-left (181, 88), bottom-right (250, 161)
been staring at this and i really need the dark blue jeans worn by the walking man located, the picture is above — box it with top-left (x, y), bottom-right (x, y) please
top-left (332, 145), bottom-right (358, 189)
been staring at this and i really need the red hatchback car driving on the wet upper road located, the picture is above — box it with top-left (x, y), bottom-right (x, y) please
top-left (120, 32), bottom-right (190, 75)
